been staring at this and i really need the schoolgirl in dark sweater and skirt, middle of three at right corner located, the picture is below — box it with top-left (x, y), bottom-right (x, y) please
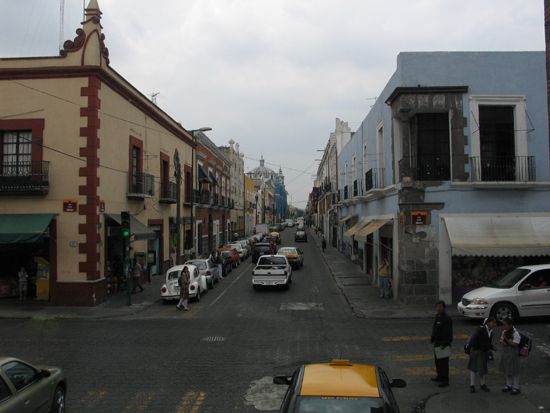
top-left (468, 317), bottom-right (497, 393)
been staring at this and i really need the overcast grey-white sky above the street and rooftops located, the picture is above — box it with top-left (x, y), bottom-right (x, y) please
top-left (0, 0), bottom-right (544, 207)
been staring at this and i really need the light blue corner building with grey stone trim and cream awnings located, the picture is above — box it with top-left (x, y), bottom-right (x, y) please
top-left (338, 52), bottom-right (550, 303)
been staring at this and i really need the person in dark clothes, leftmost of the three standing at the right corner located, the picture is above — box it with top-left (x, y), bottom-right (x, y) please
top-left (430, 301), bottom-right (453, 387)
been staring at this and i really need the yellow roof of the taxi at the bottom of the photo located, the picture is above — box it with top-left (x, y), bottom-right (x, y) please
top-left (300, 360), bottom-right (380, 397)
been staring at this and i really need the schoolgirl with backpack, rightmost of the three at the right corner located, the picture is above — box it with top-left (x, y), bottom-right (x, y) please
top-left (499, 318), bottom-right (521, 396)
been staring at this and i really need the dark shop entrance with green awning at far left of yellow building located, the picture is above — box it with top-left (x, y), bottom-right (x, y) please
top-left (0, 214), bottom-right (57, 301)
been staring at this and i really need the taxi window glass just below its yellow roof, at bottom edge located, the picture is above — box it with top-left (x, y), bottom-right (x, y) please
top-left (295, 397), bottom-right (384, 413)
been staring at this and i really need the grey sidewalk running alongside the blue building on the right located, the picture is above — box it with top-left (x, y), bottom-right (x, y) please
top-left (309, 231), bottom-right (458, 319)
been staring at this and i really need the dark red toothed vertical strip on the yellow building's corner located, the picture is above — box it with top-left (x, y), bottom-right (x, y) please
top-left (78, 76), bottom-right (101, 280)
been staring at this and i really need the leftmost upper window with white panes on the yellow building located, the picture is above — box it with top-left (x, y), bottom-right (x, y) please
top-left (0, 131), bottom-right (32, 176)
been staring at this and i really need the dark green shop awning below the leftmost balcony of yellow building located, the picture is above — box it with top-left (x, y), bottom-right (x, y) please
top-left (0, 214), bottom-right (56, 244)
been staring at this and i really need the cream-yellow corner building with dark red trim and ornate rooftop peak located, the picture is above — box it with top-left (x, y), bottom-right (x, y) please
top-left (0, 0), bottom-right (194, 305)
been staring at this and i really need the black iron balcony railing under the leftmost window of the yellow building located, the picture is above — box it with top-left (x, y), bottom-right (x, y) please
top-left (0, 161), bottom-right (50, 195)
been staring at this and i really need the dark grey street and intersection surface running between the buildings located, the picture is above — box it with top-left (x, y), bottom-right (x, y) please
top-left (0, 229), bottom-right (550, 413)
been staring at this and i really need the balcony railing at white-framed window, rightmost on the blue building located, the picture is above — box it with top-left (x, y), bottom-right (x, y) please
top-left (470, 156), bottom-right (536, 182)
